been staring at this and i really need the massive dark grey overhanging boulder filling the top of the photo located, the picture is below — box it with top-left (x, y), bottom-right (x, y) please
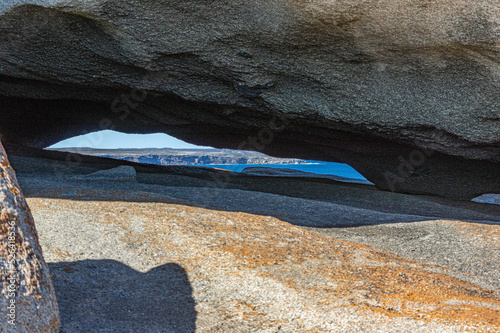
top-left (0, 0), bottom-right (500, 199)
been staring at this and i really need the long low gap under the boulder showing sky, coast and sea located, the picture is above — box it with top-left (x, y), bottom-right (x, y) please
top-left (46, 130), bottom-right (372, 184)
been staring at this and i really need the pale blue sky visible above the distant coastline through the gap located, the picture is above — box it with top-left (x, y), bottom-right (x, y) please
top-left (48, 130), bottom-right (211, 149)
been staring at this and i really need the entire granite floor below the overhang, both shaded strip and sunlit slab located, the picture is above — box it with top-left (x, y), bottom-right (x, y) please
top-left (10, 151), bottom-right (500, 333)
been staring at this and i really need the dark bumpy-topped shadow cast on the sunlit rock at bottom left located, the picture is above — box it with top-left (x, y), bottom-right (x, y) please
top-left (49, 260), bottom-right (196, 333)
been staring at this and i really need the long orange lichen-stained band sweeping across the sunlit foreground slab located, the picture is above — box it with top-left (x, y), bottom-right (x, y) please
top-left (26, 199), bottom-right (500, 332)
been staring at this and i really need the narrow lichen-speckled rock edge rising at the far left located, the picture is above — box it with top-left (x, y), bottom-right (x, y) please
top-left (0, 143), bottom-right (60, 333)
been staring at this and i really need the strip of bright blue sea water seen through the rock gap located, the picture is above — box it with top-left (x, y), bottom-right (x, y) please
top-left (196, 161), bottom-right (366, 180)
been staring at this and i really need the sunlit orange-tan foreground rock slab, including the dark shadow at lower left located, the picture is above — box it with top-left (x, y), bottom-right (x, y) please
top-left (28, 185), bottom-right (500, 333)
